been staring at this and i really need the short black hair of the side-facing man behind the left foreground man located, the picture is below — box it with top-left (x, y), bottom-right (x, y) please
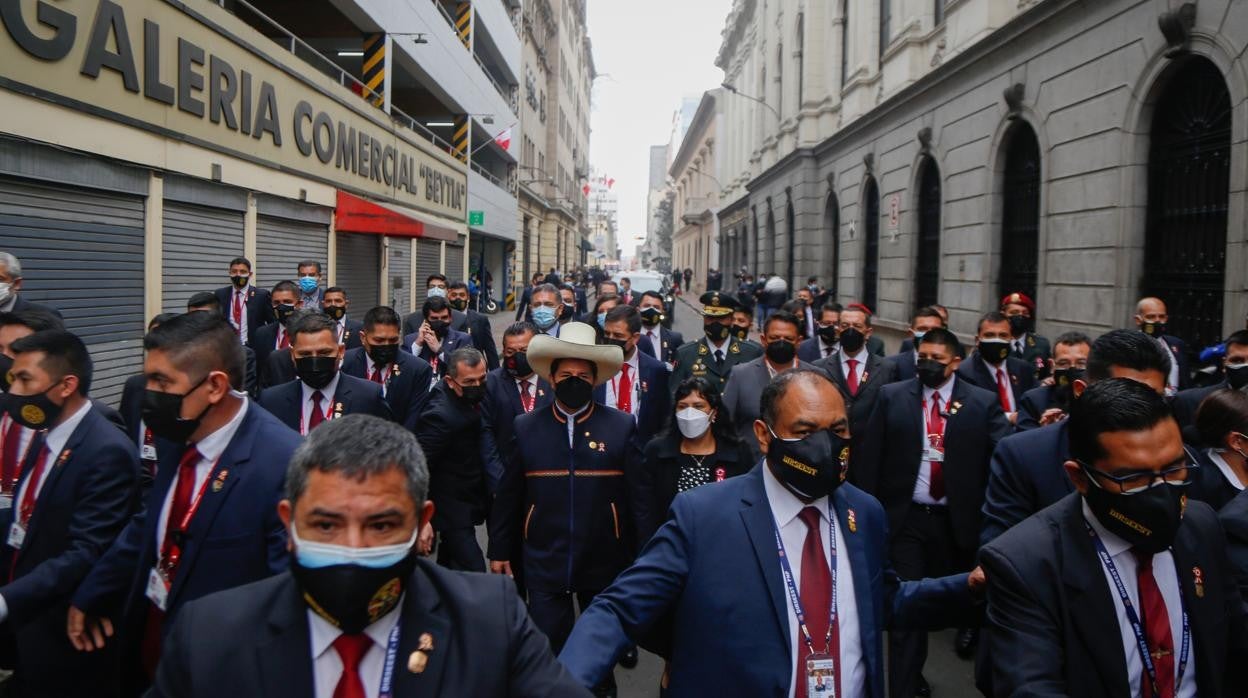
top-left (144, 312), bottom-right (243, 390)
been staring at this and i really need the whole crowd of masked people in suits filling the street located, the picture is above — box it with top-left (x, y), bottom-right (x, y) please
top-left (0, 252), bottom-right (1248, 698)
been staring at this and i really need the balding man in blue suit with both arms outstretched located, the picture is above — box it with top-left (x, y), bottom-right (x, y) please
top-left (559, 370), bottom-right (982, 698)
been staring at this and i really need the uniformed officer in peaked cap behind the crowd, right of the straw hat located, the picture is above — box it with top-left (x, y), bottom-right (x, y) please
top-left (669, 291), bottom-right (763, 392)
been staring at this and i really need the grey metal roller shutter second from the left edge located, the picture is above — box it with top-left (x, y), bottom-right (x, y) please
top-left (161, 199), bottom-right (243, 312)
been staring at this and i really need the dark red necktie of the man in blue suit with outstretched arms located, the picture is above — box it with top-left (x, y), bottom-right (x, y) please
top-left (794, 507), bottom-right (841, 698)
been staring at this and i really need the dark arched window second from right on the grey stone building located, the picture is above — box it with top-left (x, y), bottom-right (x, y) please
top-left (997, 121), bottom-right (1040, 298)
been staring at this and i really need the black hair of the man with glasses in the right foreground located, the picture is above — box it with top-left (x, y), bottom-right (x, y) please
top-left (1067, 378), bottom-right (1178, 465)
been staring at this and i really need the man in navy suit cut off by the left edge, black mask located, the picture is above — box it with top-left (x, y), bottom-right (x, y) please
top-left (0, 330), bottom-right (139, 697)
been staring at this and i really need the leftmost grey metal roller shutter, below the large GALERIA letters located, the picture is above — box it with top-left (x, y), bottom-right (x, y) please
top-left (0, 177), bottom-right (146, 405)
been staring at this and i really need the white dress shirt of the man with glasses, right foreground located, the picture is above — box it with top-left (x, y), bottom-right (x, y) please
top-left (1082, 502), bottom-right (1201, 698)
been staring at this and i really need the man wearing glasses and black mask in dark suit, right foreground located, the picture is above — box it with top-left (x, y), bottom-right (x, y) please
top-left (980, 378), bottom-right (1248, 698)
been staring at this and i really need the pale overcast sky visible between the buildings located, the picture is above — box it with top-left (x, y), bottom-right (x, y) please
top-left (588, 0), bottom-right (733, 256)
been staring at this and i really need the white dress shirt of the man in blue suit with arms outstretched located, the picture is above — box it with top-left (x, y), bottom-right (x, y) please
top-left (761, 463), bottom-right (866, 697)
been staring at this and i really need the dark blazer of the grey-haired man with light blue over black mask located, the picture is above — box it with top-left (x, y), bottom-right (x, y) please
top-left (149, 559), bottom-right (589, 698)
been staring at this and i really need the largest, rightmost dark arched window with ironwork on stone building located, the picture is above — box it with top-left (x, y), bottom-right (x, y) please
top-left (1142, 57), bottom-right (1231, 351)
